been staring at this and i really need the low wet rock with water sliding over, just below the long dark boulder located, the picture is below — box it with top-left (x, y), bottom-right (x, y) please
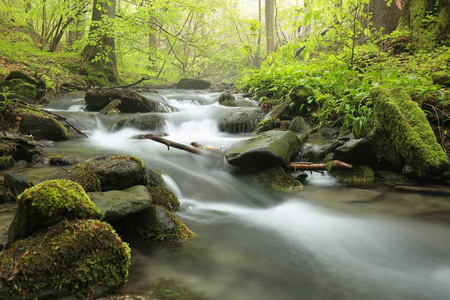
top-left (113, 113), bottom-right (166, 132)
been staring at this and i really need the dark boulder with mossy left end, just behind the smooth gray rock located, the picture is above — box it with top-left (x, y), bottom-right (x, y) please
top-left (57, 155), bottom-right (147, 192)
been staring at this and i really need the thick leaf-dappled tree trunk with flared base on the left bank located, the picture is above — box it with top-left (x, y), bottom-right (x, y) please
top-left (83, 0), bottom-right (119, 84)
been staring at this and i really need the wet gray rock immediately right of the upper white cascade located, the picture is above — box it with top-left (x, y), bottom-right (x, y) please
top-left (218, 108), bottom-right (263, 133)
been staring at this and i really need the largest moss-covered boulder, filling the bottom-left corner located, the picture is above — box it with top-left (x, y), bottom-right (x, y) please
top-left (0, 220), bottom-right (130, 299)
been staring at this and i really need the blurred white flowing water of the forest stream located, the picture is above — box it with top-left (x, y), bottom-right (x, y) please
top-left (5, 90), bottom-right (450, 300)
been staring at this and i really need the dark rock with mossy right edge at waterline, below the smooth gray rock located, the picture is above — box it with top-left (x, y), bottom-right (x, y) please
top-left (111, 205), bottom-right (195, 247)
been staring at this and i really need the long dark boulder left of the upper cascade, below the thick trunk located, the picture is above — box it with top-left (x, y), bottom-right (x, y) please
top-left (85, 89), bottom-right (166, 113)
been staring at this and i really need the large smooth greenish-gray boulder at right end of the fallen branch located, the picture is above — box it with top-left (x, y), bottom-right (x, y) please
top-left (225, 130), bottom-right (307, 167)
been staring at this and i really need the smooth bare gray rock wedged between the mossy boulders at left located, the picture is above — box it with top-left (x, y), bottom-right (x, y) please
top-left (88, 185), bottom-right (152, 222)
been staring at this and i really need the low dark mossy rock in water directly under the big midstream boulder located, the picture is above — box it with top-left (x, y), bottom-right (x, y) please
top-left (244, 167), bottom-right (303, 193)
